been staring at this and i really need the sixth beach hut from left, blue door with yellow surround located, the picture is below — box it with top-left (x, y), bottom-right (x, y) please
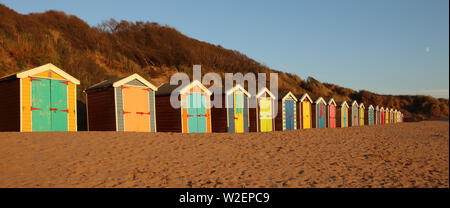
top-left (275, 92), bottom-right (298, 131)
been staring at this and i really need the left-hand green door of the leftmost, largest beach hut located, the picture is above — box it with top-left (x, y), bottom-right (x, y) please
top-left (31, 78), bottom-right (52, 131)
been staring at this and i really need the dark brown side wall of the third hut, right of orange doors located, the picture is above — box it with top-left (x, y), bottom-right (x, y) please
top-left (155, 95), bottom-right (182, 132)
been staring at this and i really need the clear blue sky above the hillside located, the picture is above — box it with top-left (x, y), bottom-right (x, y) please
top-left (0, 0), bottom-right (449, 98)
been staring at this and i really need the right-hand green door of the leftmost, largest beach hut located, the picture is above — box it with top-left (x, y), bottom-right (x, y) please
top-left (50, 79), bottom-right (67, 131)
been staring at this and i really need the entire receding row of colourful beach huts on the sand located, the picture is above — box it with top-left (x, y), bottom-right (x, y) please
top-left (0, 64), bottom-right (403, 133)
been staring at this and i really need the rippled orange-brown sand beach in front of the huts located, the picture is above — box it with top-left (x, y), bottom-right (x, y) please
top-left (0, 121), bottom-right (449, 188)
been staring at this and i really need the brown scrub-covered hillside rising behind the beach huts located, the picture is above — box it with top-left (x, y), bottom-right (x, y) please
top-left (0, 4), bottom-right (449, 129)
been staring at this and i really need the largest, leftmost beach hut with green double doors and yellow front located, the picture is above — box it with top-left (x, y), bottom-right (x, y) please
top-left (0, 64), bottom-right (80, 132)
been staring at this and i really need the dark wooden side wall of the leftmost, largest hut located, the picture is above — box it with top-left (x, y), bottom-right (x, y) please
top-left (0, 78), bottom-right (20, 131)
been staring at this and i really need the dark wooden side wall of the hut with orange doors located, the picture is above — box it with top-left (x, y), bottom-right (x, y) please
top-left (86, 87), bottom-right (116, 131)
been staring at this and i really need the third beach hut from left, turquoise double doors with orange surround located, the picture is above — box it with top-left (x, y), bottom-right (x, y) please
top-left (155, 80), bottom-right (213, 133)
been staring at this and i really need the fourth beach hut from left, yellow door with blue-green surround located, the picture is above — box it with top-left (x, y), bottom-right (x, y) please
top-left (210, 84), bottom-right (251, 133)
